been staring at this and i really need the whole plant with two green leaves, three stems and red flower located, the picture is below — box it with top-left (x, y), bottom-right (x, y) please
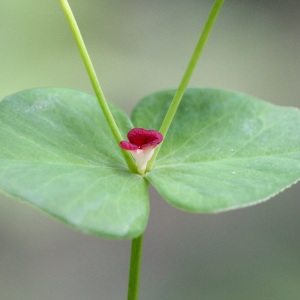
top-left (0, 0), bottom-right (300, 299)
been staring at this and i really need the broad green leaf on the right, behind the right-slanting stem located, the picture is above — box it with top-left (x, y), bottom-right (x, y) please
top-left (132, 89), bottom-right (300, 213)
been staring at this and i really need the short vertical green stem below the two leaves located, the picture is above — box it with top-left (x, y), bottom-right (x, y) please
top-left (127, 234), bottom-right (144, 300)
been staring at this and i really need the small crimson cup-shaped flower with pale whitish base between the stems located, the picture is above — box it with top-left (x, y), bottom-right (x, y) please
top-left (120, 128), bottom-right (164, 172)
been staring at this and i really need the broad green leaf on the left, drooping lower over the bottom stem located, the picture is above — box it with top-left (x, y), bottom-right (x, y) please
top-left (0, 88), bottom-right (149, 238)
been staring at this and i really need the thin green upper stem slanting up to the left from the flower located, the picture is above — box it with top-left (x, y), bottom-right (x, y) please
top-left (59, 0), bottom-right (138, 173)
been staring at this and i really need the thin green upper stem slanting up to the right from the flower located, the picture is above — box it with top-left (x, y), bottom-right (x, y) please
top-left (146, 0), bottom-right (225, 172)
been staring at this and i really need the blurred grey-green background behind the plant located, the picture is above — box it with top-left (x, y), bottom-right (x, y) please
top-left (0, 0), bottom-right (300, 300)
